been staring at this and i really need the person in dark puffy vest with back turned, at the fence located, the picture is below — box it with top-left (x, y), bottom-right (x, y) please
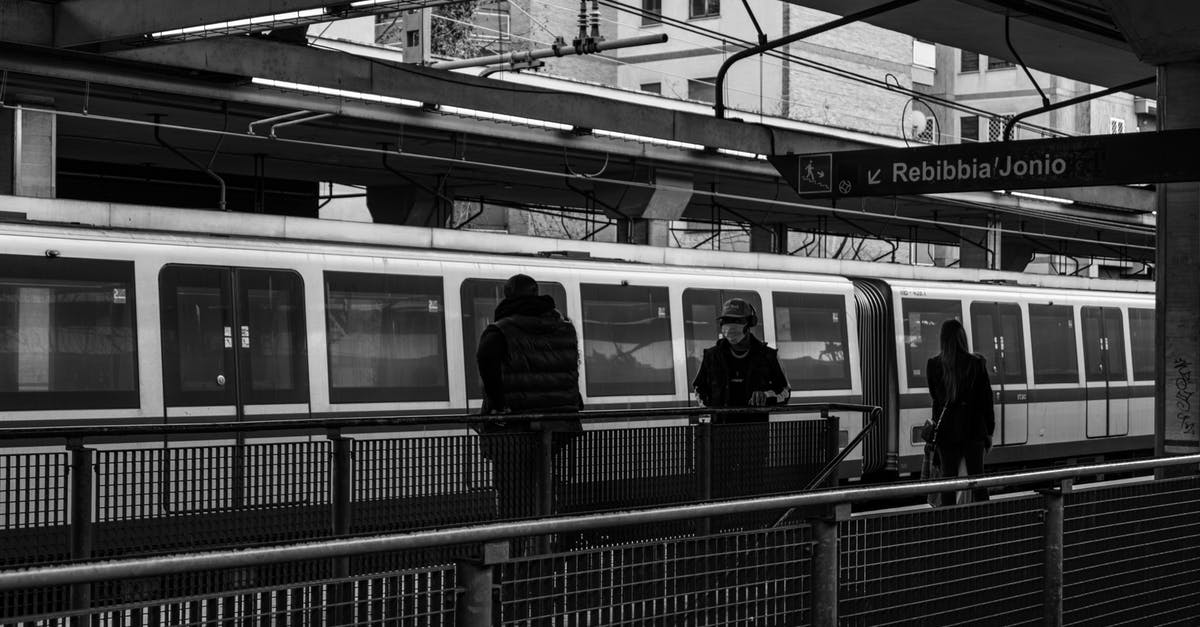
top-left (475, 274), bottom-right (583, 518)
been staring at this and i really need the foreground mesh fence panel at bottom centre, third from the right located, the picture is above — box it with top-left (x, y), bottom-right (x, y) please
top-left (499, 527), bottom-right (811, 626)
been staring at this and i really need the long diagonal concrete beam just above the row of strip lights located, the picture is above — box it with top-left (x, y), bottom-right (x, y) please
top-left (113, 37), bottom-right (772, 154)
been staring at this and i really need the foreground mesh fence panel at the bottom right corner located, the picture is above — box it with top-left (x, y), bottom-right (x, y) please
top-left (1063, 477), bottom-right (1200, 625)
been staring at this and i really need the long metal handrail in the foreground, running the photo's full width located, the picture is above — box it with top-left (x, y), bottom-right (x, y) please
top-left (0, 454), bottom-right (1200, 591)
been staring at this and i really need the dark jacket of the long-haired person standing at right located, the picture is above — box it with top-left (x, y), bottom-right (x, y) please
top-left (925, 354), bottom-right (996, 446)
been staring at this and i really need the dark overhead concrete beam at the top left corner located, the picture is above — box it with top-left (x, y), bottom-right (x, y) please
top-left (55, 0), bottom-right (344, 48)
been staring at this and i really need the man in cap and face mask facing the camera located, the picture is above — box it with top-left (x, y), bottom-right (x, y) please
top-left (691, 298), bottom-right (791, 497)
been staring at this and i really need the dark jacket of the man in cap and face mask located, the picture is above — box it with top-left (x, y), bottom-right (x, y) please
top-left (691, 335), bottom-right (788, 420)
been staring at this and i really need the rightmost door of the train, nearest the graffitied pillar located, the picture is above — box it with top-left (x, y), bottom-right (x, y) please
top-left (1080, 307), bottom-right (1129, 437)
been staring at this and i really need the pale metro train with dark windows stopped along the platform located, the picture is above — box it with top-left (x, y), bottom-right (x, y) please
top-left (0, 198), bottom-right (1154, 477)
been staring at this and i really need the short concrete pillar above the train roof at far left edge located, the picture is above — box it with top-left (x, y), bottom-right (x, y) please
top-left (0, 107), bottom-right (58, 198)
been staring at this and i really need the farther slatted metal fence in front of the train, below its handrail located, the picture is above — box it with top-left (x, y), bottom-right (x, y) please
top-left (0, 404), bottom-right (878, 567)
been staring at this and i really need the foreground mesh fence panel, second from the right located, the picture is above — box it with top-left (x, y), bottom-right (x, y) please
top-left (839, 497), bottom-right (1045, 626)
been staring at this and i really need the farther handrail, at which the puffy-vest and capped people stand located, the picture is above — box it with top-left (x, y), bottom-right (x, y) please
top-left (0, 402), bottom-right (876, 441)
